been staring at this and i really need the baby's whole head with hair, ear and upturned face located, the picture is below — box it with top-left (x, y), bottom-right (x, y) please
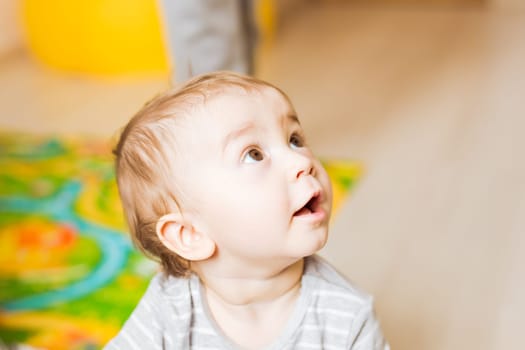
top-left (115, 72), bottom-right (332, 276)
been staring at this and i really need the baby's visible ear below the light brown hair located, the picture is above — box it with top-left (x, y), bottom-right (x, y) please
top-left (156, 213), bottom-right (215, 261)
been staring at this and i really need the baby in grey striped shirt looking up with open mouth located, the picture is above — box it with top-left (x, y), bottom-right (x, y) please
top-left (106, 72), bottom-right (389, 350)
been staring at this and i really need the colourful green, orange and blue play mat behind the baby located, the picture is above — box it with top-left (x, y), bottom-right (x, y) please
top-left (0, 132), bottom-right (361, 349)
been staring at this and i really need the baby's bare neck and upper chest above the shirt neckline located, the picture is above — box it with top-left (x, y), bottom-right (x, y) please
top-left (195, 259), bottom-right (304, 349)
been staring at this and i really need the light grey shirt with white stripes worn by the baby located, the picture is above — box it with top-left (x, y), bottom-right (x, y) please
top-left (105, 255), bottom-right (390, 350)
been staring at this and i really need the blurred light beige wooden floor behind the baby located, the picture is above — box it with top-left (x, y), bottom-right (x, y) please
top-left (0, 2), bottom-right (525, 350)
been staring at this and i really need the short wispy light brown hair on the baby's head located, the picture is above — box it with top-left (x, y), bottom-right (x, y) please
top-left (113, 72), bottom-right (289, 277)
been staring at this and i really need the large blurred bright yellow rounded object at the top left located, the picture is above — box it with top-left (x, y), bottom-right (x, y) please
top-left (21, 0), bottom-right (168, 75)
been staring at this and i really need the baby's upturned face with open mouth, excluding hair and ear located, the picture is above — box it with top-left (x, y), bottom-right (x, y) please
top-left (176, 88), bottom-right (332, 270)
